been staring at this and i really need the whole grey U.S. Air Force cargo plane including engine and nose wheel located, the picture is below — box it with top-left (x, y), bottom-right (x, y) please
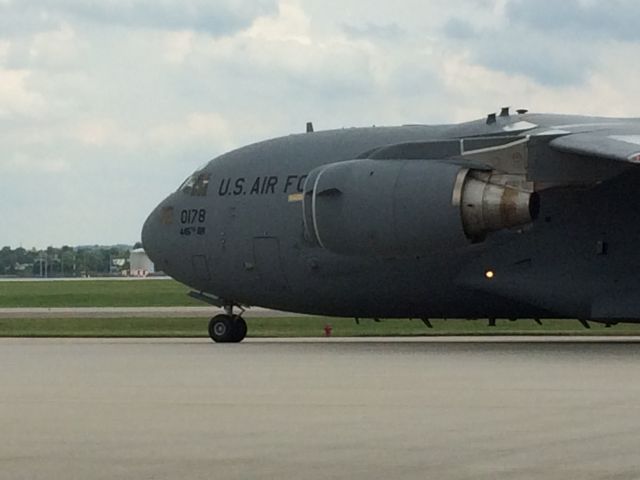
top-left (142, 108), bottom-right (640, 342)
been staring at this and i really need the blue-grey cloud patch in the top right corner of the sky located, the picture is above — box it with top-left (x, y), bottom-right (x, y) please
top-left (442, 0), bottom-right (640, 88)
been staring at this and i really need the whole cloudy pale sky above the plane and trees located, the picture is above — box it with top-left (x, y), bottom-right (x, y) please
top-left (0, 0), bottom-right (640, 248)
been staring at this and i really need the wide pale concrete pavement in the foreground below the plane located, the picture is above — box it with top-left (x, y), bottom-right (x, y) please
top-left (0, 338), bottom-right (640, 480)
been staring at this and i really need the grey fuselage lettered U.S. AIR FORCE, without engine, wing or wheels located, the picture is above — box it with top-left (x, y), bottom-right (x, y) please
top-left (143, 115), bottom-right (640, 318)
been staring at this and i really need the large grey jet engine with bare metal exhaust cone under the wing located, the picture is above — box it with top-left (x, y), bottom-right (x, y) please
top-left (303, 159), bottom-right (537, 256)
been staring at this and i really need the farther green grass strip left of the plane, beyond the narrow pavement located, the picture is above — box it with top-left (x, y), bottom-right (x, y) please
top-left (0, 280), bottom-right (203, 308)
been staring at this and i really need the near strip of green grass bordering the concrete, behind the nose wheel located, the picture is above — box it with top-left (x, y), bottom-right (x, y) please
top-left (0, 317), bottom-right (640, 337)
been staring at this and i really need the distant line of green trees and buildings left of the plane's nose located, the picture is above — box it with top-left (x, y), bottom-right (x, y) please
top-left (0, 243), bottom-right (140, 277)
